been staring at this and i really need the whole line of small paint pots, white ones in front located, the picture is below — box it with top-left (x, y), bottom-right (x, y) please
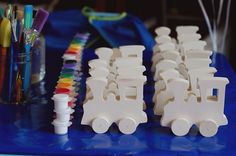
top-left (52, 33), bottom-right (89, 134)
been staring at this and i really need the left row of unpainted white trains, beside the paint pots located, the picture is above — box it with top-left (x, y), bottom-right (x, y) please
top-left (81, 45), bottom-right (147, 134)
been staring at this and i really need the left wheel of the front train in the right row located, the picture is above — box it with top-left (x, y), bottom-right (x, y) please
top-left (171, 118), bottom-right (191, 136)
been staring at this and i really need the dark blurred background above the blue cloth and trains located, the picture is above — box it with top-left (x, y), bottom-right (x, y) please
top-left (0, 0), bottom-right (236, 69)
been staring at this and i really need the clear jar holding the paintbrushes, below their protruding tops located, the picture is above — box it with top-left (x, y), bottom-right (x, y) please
top-left (0, 52), bottom-right (32, 104)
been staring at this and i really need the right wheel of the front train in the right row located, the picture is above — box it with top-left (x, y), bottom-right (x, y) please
top-left (199, 120), bottom-right (218, 137)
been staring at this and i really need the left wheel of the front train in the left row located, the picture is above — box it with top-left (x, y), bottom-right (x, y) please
top-left (92, 117), bottom-right (110, 133)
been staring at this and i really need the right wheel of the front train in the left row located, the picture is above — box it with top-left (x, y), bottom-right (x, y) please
top-left (118, 118), bottom-right (137, 134)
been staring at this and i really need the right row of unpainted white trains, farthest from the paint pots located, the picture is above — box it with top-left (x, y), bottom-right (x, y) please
top-left (152, 26), bottom-right (229, 137)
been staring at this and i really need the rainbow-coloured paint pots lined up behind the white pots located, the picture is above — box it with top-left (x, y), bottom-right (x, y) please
top-left (54, 33), bottom-right (89, 108)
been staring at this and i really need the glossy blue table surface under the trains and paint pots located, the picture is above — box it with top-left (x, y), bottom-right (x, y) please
top-left (0, 9), bottom-right (236, 156)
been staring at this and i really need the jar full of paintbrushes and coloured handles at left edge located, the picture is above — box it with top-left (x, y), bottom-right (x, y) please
top-left (0, 5), bottom-right (49, 104)
